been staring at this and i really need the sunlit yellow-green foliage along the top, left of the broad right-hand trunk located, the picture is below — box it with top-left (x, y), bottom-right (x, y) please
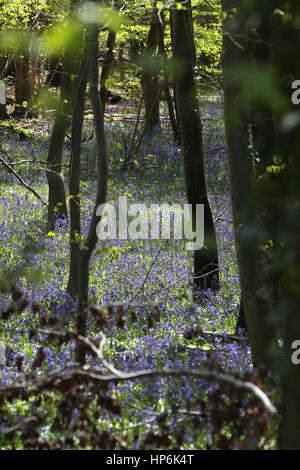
top-left (0, 0), bottom-right (222, 89)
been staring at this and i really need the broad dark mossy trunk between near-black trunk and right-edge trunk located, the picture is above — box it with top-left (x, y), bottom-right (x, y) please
top-left (222, 0), bottom-right (279, 366)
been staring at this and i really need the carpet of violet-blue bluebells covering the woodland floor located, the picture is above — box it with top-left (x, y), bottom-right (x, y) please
top-left (0, 97), bottom-right (262, 448)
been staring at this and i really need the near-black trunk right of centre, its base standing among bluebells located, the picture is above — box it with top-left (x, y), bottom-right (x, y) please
top-left (171, 2), bottom-right (219, 289)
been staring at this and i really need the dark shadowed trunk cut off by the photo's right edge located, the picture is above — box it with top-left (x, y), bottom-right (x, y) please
top-left (266, 1), bottom-right (300, 450)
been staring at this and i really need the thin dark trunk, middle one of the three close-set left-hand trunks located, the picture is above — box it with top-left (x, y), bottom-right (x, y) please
top-left (67, 60), bottom-right (88, 298)
